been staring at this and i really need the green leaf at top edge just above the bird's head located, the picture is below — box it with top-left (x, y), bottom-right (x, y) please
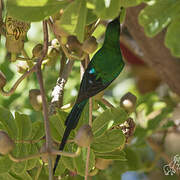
top-left (93, 0), bottom-right (121, 19)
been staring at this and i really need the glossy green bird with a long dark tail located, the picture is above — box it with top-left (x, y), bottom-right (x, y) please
top-left (53, 17), bottom-right (125, 174)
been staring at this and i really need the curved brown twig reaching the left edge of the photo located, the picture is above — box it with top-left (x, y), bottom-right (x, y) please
top-left (0, 66), bottom-right (36, 96)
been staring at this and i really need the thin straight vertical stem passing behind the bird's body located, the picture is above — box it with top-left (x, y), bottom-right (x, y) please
top-left (85, 56), bottom-right (93, 180)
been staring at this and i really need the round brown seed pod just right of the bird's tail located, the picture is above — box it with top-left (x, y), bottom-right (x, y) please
top-left (74, 124), bottom-right (93, 147)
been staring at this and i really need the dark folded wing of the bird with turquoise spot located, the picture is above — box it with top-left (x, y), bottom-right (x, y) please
top-left (76, 64), bottom-right (114, 103)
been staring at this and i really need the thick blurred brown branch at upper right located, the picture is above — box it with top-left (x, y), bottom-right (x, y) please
top-left (125, 5), bottom-right (180, 95)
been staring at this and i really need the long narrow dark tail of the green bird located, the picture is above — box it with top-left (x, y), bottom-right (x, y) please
top-left (53, 100), bottom-right (87, 174)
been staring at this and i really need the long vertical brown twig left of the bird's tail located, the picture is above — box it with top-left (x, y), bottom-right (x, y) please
top-left (36, 20), bottom-right (53, 180)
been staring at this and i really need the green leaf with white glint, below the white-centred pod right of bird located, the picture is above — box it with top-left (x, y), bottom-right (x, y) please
top-left (92, 107), bottom-right (128, 136)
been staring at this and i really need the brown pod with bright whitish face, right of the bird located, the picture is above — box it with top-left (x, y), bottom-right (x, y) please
top-left (120, 92), bottom-right (137, 113)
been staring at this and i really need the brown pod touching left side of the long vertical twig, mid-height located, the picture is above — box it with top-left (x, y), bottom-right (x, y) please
top-left (29, 89), bottom-right (42, 111)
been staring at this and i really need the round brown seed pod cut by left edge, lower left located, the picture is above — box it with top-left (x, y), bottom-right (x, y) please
top-left (0, 131), bottom-right (14, 155)
